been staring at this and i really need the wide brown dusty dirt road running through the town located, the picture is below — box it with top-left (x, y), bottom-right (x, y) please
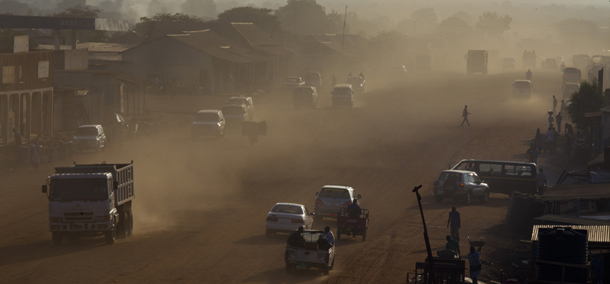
top-left (0, 72), bottom-right (561, 283)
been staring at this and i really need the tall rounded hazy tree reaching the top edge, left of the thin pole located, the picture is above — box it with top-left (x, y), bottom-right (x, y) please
top-left (276, 0), bottom-right (332, 35)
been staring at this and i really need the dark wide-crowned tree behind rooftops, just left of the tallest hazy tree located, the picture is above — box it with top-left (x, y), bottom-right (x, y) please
top-left (216, 6), bottom-right (282, 36)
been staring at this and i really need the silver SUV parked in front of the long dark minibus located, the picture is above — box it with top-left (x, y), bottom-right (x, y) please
top-left (432, 170), bottom-right (489, 204)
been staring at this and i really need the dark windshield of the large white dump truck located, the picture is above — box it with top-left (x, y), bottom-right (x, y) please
top-left (49, 178), bottom-right (108, 201)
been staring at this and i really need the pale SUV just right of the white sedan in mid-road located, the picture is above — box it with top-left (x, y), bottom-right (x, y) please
top-left (313, 185), bottom-right (362, 222)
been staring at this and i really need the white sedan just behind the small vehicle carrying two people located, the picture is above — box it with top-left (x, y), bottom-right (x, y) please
top-left (265, 202), bottom-right (313, 237)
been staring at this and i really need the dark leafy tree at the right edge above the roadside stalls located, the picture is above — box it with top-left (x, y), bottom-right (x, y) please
top-left (566, 79), bottom-right (606, 127)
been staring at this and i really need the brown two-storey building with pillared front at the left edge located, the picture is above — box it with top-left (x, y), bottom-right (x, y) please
top-left (0, 51), bottom-right (54, 145)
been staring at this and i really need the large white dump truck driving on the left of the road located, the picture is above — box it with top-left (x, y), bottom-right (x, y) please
top-left (42, 161), bottom-right (135, 245)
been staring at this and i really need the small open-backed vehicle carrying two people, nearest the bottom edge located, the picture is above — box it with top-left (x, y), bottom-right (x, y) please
top-left (284, 230), bottom-right (335, 275)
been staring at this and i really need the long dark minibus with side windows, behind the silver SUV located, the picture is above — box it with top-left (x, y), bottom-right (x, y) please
top-left (452, 159), bottom-right (538, 195)
